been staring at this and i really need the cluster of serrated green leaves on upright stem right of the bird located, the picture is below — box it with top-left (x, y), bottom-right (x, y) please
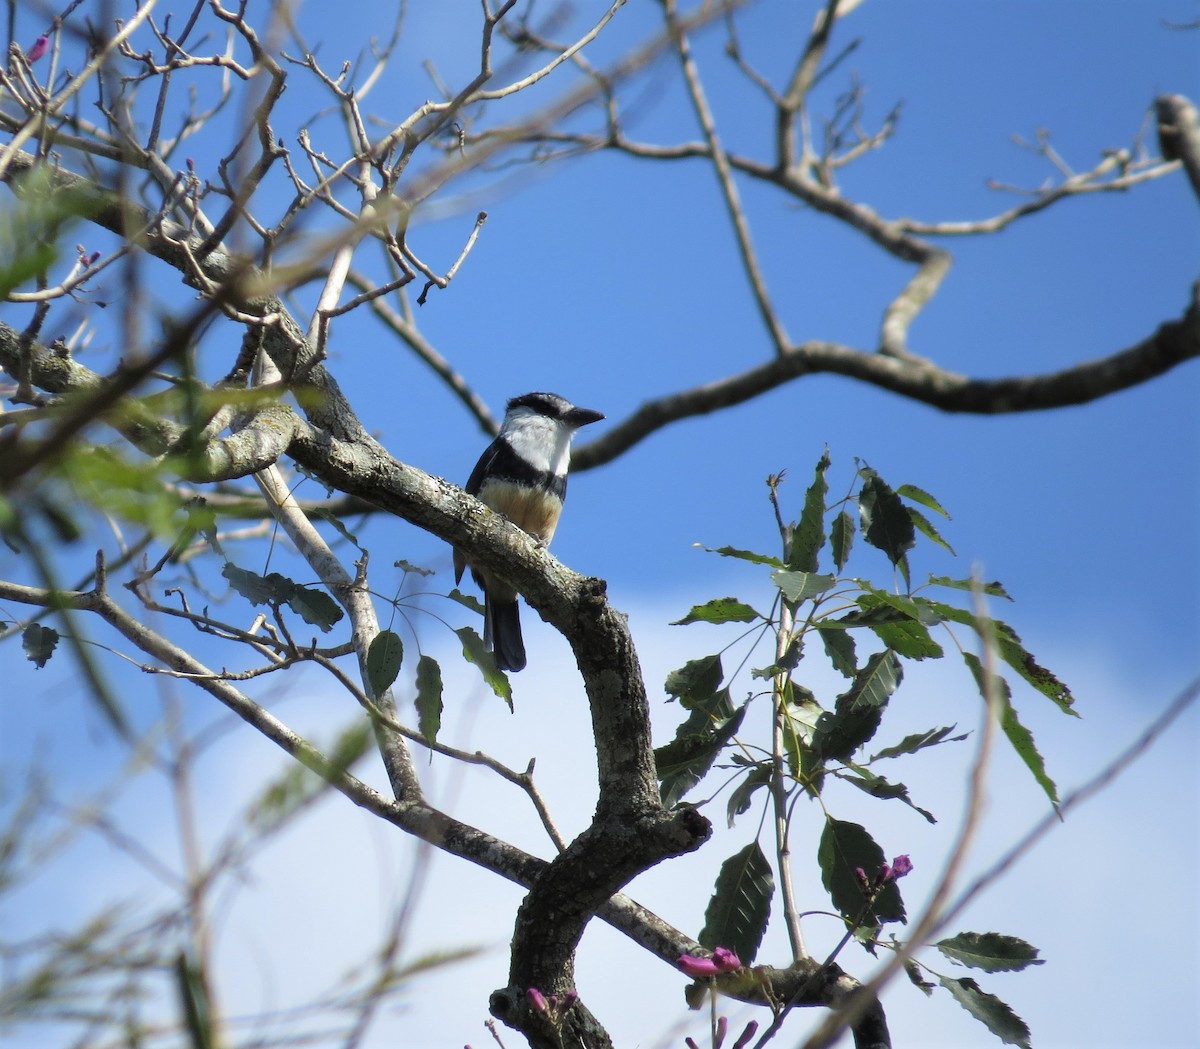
top-left (655, 451), bottom-right (1074, 1044)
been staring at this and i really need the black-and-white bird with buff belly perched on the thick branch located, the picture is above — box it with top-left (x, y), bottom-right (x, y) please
top-left (454, 392), bottom-right (604, 671)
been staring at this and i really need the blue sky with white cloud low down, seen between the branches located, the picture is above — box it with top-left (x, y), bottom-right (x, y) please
top-left (0, 0), bottom-right (1200, 1049)
